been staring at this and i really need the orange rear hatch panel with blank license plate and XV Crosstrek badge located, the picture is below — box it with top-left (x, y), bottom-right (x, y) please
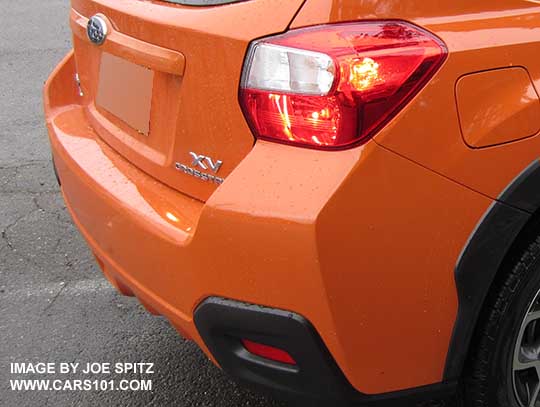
top-left (71, 0), bottom-right (303, 201)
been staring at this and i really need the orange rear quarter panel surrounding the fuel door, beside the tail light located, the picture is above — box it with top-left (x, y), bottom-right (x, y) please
top-left (292, 0), bottom-right (540, 198)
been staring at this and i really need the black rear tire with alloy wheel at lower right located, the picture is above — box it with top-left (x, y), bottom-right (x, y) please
top-left (464, 237), bottom-right (540, 407)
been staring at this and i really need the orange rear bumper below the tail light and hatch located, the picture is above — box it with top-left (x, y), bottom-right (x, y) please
top-left (45, 54), bottom-right (490, 399)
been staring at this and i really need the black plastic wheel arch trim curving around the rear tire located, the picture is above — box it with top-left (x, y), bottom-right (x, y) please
top-left (444, 160), bottom-right (540, 380)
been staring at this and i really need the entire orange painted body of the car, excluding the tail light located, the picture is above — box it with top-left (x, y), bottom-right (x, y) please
top-left (45, 0), bottom-right (540, 404)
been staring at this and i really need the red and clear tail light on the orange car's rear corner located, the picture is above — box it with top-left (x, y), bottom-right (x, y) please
top-left (240, 21), bottom-right (447, 149)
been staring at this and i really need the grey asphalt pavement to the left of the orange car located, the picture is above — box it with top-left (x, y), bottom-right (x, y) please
top-left (0, 0), bottom-right (281, 407)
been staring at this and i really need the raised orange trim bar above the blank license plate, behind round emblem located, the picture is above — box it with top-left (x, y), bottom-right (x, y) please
top-left (70, 9), bottom-right (186, 76)
